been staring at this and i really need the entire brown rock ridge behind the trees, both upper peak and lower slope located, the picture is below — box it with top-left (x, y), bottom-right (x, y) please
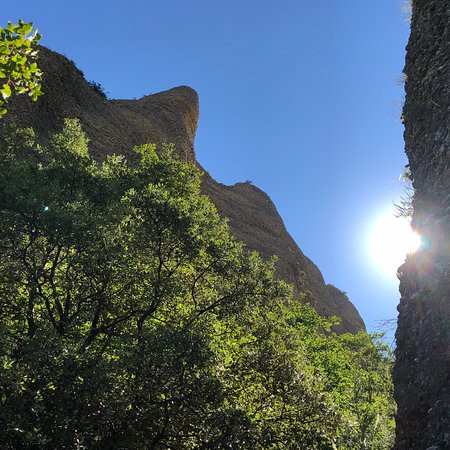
top-left (6, 48), bottom-right (364, 332)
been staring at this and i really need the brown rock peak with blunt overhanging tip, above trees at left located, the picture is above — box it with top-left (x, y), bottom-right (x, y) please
top-left (7, 47), bottom-right (198, 161)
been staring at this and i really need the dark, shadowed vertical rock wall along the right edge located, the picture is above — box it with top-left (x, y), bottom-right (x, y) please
top-left (394, 0), bottom-right (450, 450)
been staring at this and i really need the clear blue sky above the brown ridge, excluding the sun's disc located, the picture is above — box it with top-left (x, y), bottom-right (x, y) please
top-left (0, 0), bottom-right (409, 338)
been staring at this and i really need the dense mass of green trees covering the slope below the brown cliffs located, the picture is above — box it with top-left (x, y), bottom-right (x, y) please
top-left (0, 120), bottom-right (393, 449)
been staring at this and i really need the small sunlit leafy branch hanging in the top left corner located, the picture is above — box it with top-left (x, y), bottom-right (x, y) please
top-left (0, 20), bottom-right (42, 118)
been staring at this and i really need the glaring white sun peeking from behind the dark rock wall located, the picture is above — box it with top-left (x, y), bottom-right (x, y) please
top-left (369, 211), bottom-right (421, 277)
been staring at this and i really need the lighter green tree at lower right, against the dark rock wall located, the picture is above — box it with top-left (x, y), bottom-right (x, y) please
top-left (297, 307), bottom-right (396, 450)
